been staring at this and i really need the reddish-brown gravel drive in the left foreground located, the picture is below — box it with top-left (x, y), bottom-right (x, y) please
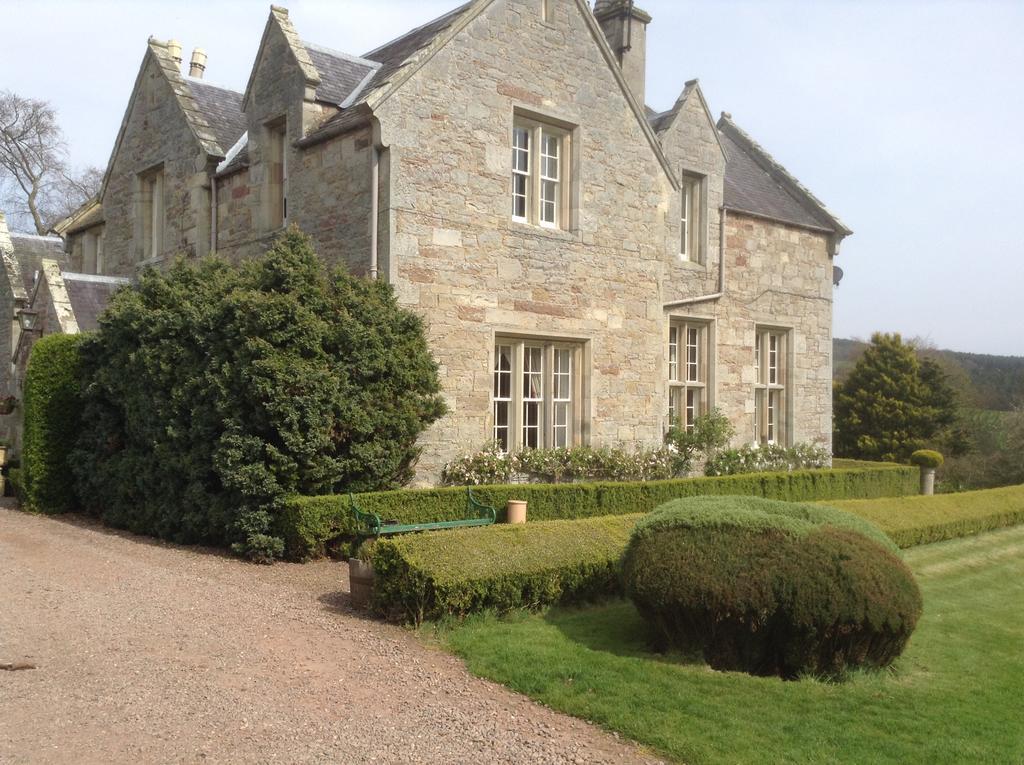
top-left (0, 501), bottom-right (650, 765)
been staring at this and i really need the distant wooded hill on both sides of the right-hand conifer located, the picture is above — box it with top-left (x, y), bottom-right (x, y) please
top-left (833, 338), bottom-right (1024, 412)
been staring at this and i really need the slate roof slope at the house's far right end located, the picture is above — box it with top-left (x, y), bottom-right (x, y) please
top-left (718, 114), bottom-right (853, 237)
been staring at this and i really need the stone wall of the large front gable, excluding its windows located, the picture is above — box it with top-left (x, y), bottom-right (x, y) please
top-left (378, 0), bottom-right (678, 481)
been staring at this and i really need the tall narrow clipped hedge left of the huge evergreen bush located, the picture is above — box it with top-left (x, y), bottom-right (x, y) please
top-left (22, 335), bottom-right (83, 513)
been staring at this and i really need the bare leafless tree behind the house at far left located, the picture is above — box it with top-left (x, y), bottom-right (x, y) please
top-left (0, 91), bottom-right (102, 235)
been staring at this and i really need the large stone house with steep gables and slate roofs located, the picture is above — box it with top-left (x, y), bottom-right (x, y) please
top-left (69, 0), bottom-right (851, 482)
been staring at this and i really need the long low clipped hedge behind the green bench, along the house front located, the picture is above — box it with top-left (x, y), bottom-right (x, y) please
top-left (273, 463), bottom-right (919, 559)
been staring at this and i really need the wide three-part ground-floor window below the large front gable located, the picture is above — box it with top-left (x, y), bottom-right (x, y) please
top-left (492, 338), bottom-right (583, 452)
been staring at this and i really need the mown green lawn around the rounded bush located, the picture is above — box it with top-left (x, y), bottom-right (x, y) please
top-left (438, 526), bottom-right (1024, 765)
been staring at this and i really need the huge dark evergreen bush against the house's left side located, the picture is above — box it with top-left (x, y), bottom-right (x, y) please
top-left (75, 228), bottom-right (444, 559)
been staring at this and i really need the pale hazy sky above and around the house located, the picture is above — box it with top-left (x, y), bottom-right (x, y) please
top-left (0, 0), bottom-right (1024, 355)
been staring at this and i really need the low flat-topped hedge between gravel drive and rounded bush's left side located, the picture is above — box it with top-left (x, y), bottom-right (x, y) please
top-left (372, 515), bottom-right (641, 624)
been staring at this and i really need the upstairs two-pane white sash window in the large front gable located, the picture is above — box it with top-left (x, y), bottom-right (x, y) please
top-left (512, 117), bottom-right (571, 228)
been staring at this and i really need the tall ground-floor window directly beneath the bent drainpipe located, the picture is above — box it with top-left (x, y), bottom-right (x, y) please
top-left (669, 320), bottom-right (711, 430)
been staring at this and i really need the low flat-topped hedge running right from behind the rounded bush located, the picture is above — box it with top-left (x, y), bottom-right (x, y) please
top-left (828, 485), bottom-right (1024, 547)
